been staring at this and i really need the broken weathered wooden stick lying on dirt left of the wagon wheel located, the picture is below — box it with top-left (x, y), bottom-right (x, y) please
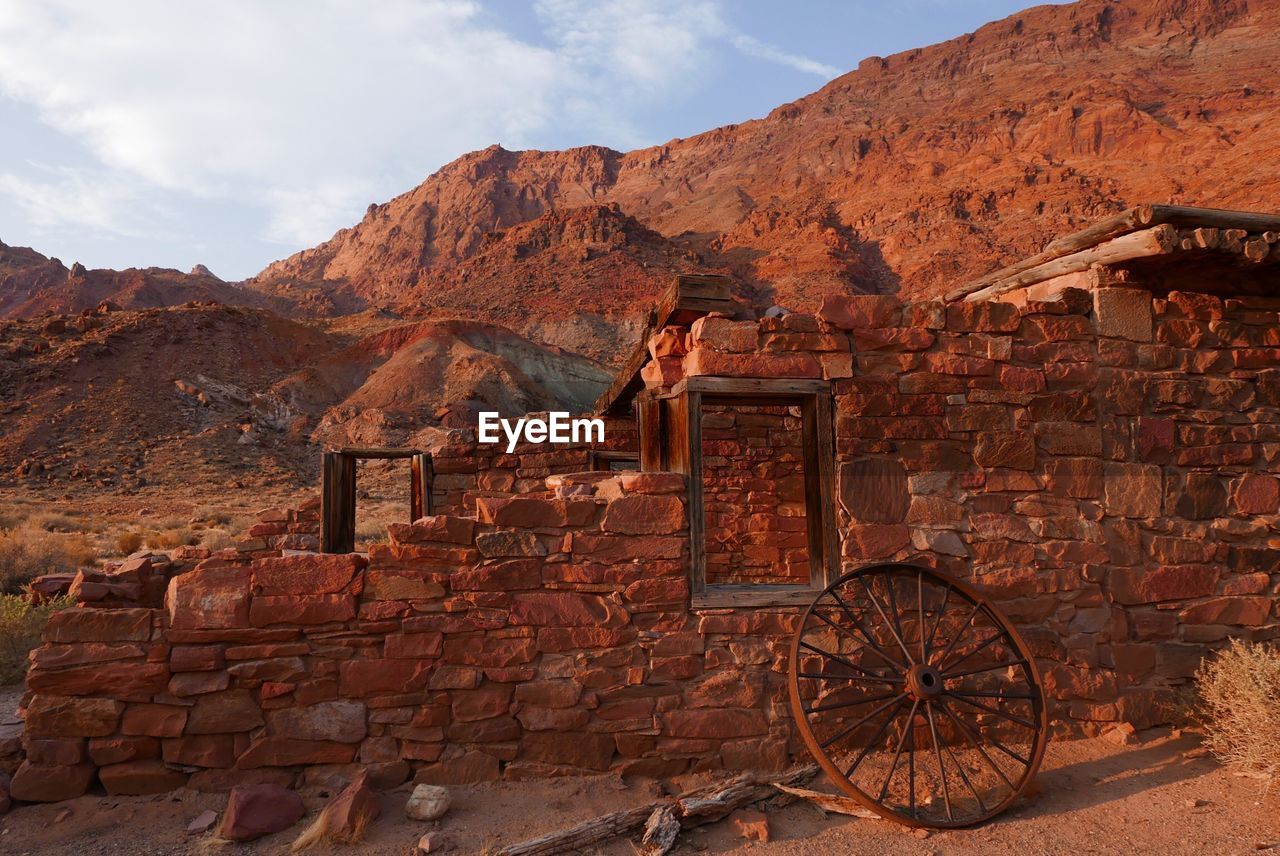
top-left (498, 764), bottom-right (818, 856)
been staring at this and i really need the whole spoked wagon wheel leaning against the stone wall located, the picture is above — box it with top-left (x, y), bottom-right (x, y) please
top-left (790, 563), bottom-right (1048, 828)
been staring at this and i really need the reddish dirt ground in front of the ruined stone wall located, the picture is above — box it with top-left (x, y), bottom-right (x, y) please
top-left (0, 736), bottom-right (1280, 856)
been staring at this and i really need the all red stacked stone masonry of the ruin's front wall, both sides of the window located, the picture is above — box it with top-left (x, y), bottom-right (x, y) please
top-left (13, 289), bottom-right (1280, 800)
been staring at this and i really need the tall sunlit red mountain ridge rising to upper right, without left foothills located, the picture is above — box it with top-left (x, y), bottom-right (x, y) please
top-left (250, 0), bottom-right (1280, 357)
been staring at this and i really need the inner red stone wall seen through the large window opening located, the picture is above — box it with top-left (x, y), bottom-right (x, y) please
top-left (701, 404), bottom-right (809, 585)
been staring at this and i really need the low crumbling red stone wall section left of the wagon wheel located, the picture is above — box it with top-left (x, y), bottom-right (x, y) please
top-left (13, 473), bottom-right (791, 800)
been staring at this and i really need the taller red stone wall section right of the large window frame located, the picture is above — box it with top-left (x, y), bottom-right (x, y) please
top-left (666, 288), bottom-right (1280, 733)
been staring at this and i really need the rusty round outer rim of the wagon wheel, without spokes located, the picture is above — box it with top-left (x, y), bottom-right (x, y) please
top-left (787, 562), bottom-right (1048, 829)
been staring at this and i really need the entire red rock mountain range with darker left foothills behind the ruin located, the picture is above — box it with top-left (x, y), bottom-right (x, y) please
top-left (0, 0), bottom-right (1280, 486)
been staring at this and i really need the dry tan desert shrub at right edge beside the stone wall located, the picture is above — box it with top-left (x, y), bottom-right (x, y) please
top-left (1196, 640), bottom-right (1280, 784)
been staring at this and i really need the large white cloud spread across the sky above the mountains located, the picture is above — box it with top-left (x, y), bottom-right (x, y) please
top-left (0, 0), bottom-right (827, 261)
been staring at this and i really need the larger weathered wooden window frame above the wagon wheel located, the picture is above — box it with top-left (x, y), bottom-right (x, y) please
top-left (650, 377), bottom-right (840, 609)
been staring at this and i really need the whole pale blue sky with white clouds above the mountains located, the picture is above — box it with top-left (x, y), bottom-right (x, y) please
top-left (0, 0), bottom-right (1029, 280)
